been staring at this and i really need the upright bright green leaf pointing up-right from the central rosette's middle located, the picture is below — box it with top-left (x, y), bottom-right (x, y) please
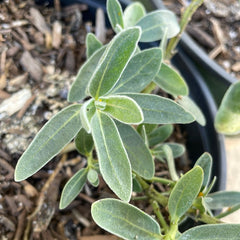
top-left (89, 27), bottom-right (141, 99)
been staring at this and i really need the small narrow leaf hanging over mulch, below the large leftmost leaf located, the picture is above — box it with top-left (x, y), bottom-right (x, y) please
top-left (59, 168), bottom-right (88, 209)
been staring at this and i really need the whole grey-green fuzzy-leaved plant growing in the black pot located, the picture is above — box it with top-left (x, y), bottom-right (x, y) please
top-left (15, 0), bottom-right (240, 240)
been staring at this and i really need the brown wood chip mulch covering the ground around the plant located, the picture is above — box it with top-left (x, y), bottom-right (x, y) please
top-left (0, 0), bottom-right (236, 240)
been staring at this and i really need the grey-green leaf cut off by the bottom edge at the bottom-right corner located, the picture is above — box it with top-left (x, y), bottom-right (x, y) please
top-left (178, 224), bottom-right (240, 240)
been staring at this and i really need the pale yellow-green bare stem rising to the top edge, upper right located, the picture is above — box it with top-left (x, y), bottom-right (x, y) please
top-left (165, 0), bottom-right (204, 60)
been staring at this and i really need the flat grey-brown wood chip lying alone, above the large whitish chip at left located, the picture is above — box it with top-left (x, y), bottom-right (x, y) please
top-left (20, 51), bottom-right (43, 82)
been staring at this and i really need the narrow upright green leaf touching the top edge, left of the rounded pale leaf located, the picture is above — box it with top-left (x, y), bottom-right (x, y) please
top-left (107, 0), bottom-right (124, 32)
